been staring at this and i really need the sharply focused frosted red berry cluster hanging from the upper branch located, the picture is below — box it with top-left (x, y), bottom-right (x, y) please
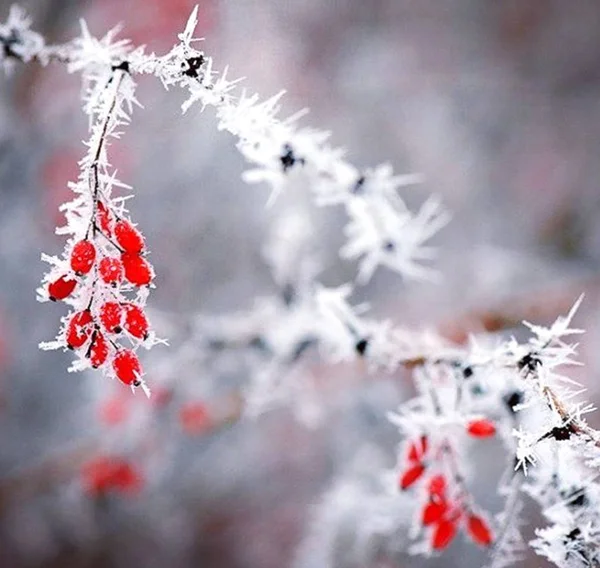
top-left (47, 197), bottom-right (154, 386)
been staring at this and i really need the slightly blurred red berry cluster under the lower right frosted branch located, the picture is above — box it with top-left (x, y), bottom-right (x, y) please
top-left (398, 426), bottom-right (496, 550)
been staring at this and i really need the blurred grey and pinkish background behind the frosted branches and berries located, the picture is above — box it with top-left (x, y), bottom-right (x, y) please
top-left (0, 0), bottom-right (600, 568)
